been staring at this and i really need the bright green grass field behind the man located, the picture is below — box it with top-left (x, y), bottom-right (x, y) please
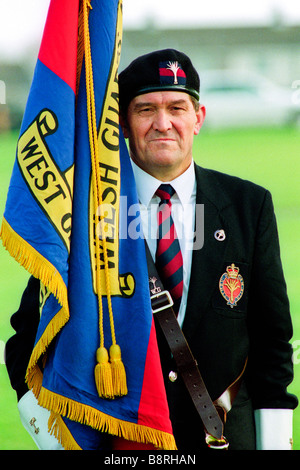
top-left (0, 129), bottom-right (300, 450)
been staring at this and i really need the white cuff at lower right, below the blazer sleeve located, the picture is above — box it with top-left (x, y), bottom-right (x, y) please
top-left (254, 408), bottom-right (293, 450)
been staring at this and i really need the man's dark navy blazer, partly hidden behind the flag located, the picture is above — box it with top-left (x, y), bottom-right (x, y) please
top-left (6, 165), bottom-right (297, 451)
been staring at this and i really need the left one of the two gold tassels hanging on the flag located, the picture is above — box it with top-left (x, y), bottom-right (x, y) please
top-left (95, 346), bottom-right (114, 398)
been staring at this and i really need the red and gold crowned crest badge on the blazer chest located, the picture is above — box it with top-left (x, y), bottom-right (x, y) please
top-left (219, 263), bottom-right (244, 308)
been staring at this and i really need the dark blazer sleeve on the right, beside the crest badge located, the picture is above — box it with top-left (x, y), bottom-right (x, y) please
top-left (247, 191), bottom-right (298, 409)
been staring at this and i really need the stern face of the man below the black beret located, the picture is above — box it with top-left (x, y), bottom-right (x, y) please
top-left (123, 91), bottom-right (205, 181)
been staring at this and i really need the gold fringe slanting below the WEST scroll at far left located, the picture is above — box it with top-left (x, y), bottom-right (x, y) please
top-left (0, 217), bottom-right (69, 314)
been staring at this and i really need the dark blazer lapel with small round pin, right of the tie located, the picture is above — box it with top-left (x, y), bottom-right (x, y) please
top-left (182, 165), bottom-right (231, 340)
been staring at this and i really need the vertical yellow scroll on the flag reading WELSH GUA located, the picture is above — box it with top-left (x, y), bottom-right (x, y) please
top-left (90, 2), bottom-right (135, 297)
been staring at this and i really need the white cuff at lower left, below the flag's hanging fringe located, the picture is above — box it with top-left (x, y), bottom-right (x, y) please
top-left (18, 390), bottom-right (64, 450)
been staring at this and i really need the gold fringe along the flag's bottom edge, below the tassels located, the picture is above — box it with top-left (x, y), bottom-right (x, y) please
top-left (38, 387), bottom-right (177, 450)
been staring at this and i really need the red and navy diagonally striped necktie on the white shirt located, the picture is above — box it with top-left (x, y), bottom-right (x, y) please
top-left (155, 184), bottom-right (183, 313)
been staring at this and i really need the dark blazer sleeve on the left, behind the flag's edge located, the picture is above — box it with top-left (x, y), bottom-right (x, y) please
top-left (5, 277), bottom-right (40, 400)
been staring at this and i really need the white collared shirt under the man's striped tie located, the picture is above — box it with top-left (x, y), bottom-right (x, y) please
top-left (132, 162), bottom-right (196, 326)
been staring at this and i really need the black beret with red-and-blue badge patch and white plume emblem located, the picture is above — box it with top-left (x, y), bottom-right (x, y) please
top-left (119, 49), bottom-right (200, 112)
